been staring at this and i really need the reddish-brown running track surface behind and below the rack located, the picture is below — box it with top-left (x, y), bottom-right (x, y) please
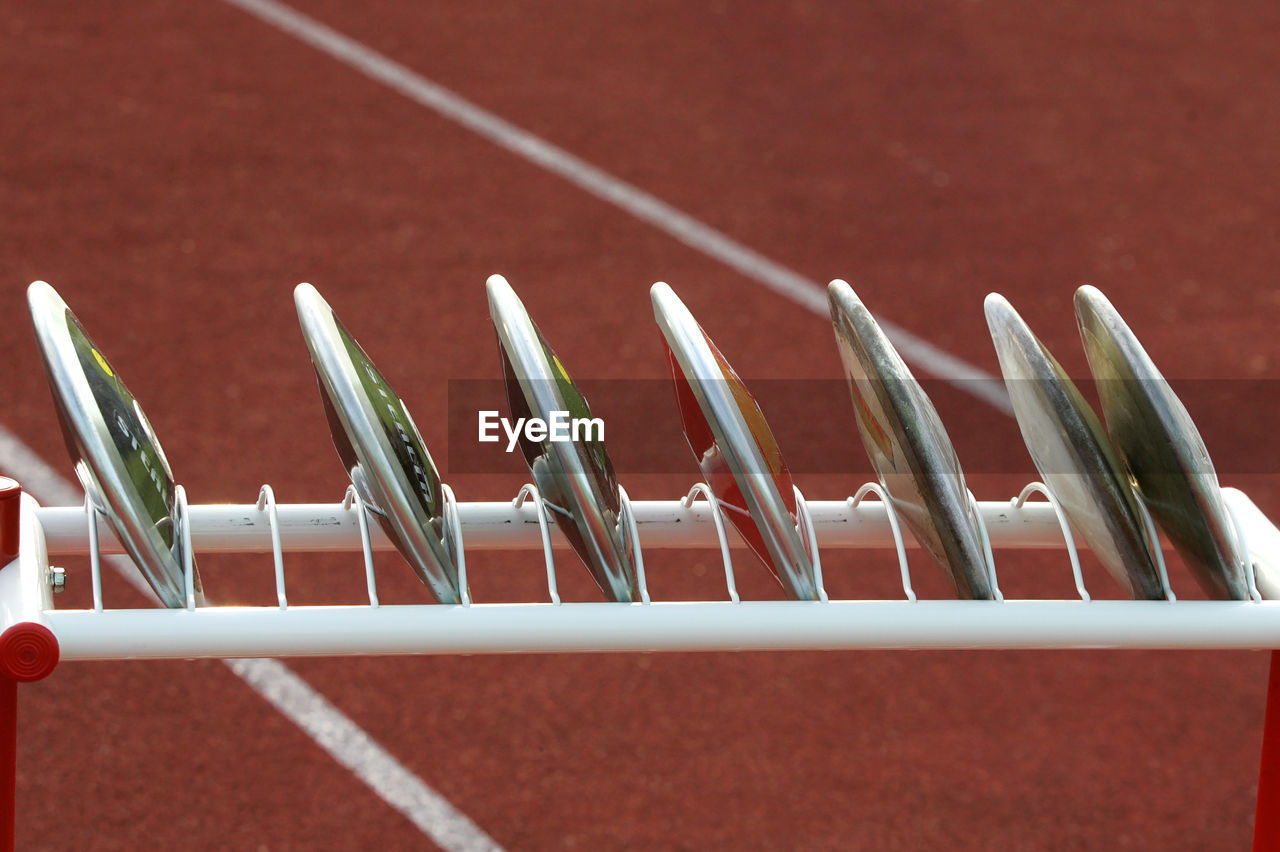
top-left (0, 0), bottom-right (1280, 851)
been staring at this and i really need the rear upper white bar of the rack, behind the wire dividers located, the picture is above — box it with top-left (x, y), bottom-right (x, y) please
top-left (37, 500), bottom-right (1062, 555)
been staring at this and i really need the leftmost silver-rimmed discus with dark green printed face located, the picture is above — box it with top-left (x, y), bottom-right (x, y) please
top-left (27, 281), bottom-right (205, 608)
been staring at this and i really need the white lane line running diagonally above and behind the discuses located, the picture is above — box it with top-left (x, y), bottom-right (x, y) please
top-left (224, 0), bottom-right (1014, 414)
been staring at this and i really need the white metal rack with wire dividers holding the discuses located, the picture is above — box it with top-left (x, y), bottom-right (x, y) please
top-left (0, 484), bottom-right (1280, 660)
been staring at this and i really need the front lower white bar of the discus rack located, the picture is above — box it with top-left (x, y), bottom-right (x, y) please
top-left (46, 600), bottom-right (1280, 660)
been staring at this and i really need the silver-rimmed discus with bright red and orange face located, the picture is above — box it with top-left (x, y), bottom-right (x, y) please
top-left (650, 283), bottom-right (818, 600)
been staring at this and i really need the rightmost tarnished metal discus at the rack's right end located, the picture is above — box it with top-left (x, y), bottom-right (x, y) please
top-left (1075, 285), bottom-right (1249, 600)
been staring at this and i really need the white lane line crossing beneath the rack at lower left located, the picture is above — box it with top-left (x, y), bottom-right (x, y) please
top-left (0, 426), bottom-right (502, 852)
